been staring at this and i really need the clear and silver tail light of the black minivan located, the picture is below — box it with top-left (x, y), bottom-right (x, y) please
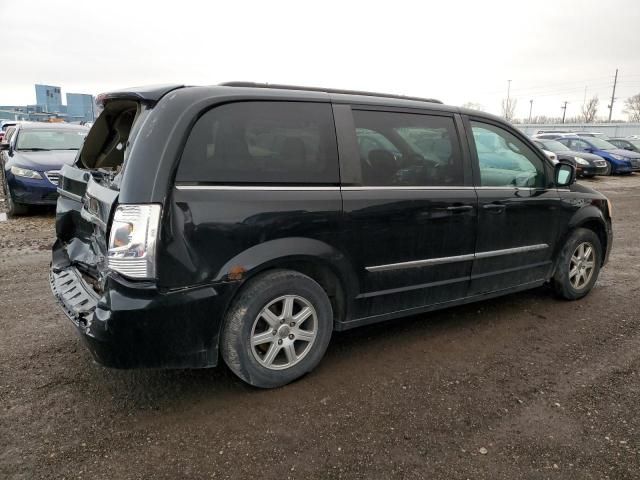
top-left (107, 205), bottom-right (160, 278)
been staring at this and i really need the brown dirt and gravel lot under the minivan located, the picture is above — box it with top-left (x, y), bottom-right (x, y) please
top-left (0, 175), bottom-right (640, 479)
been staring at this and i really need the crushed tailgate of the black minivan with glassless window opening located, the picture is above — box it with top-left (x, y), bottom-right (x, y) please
top-left (52, 98), bottom-right (150, 300)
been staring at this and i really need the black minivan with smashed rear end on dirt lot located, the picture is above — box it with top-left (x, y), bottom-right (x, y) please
top-left (50, 83), bottom-right (612, 387)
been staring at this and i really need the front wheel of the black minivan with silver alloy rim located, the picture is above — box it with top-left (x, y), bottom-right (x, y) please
top-left (552, 228), bottom-right (602, 300)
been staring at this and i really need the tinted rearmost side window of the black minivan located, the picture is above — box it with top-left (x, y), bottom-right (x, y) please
top-left (176, 102), bottom-right (339, 184)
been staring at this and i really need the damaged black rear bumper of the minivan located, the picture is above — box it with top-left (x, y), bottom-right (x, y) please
top-left (50, 242), bottom-right (231, 368)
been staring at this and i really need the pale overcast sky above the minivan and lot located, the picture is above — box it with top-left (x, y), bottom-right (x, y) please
top-left (0, 0), bottom-right (640, 120)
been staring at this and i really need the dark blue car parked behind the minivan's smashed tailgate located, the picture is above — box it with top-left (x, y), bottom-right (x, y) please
top-left (0, 123), bottom-right (89, 216)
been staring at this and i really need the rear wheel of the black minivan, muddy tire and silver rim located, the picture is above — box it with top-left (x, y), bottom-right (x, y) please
top-left (220, 270), bottom-right (333, 388)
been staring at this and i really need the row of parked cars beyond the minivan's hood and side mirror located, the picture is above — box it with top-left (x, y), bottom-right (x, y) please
top-left (532, 131), bottom-right (640, 177)
